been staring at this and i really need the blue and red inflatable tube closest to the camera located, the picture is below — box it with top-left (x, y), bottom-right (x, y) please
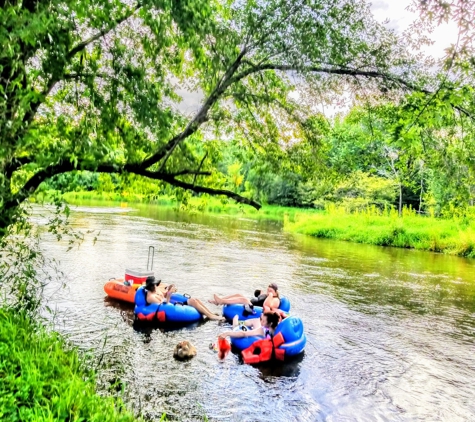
top-left (231, 316), bottom-right (307, 363)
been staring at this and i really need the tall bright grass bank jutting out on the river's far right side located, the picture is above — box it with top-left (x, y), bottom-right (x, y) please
top-left (284, 207), bottom-right (475, 258)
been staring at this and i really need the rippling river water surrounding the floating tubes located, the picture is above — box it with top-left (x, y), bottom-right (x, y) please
top-left (37, 206), bottom-right (475, 422)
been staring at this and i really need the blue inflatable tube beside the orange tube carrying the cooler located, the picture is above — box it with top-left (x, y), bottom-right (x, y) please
top-left (134, 287), bottom-right (203, 324)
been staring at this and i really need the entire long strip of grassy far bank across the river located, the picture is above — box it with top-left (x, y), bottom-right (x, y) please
top-left (47, 192), bottom-right (475, 258)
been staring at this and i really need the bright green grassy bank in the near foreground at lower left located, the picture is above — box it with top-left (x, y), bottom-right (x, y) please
top-left (0, 308), bottom-right (136, 422)
